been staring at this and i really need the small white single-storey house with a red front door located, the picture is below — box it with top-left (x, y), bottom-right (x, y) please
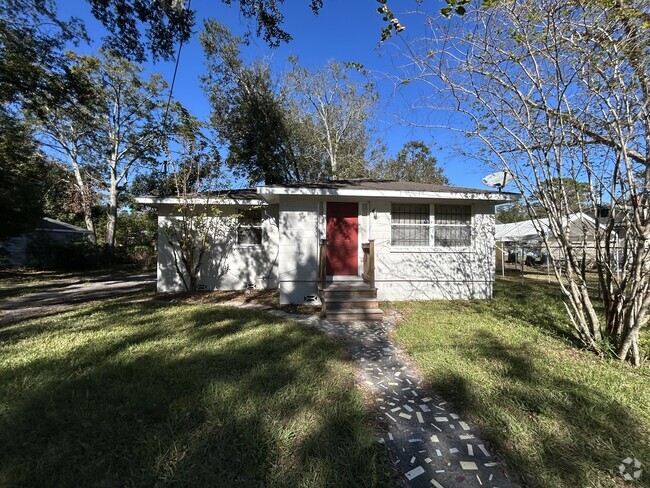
top-left (137, 179), bottom-right (513, 303)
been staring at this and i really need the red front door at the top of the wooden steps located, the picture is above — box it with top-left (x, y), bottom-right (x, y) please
top-left (327, 202), bottom-right (359, 276)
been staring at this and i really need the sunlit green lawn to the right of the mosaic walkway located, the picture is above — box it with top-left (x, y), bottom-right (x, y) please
top-left (391, 279), bottom-right (650, 488)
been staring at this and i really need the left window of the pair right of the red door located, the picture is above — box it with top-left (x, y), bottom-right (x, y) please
top-left (390, 203), bottom-right (431, 246)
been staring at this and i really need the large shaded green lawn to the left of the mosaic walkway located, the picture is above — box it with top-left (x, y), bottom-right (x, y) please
top-left (0, 301), bottom-right (392, 487)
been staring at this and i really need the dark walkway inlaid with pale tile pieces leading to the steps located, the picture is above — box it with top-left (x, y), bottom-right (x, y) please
top-left (258, 311), bottom-right (517, 488)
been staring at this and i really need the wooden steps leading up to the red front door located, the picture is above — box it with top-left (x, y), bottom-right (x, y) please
top-left (318, 281), bottom-right (384, 321)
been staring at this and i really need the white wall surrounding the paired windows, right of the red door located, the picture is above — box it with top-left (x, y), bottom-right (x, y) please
top-left (369, 200), bottom-right (495, 300)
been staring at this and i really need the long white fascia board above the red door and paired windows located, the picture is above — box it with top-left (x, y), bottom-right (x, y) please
top-left (257, 186), bottom-right (516, 203)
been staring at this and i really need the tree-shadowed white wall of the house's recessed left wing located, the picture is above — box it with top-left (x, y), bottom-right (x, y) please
top-left (157, 205), bottom-right (279, 292)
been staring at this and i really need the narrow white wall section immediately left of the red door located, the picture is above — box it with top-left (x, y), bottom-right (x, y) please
top-left (279, 196), bottom-right (320, 304)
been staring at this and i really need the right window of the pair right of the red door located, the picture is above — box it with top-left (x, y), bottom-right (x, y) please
top-left (433, 205), bottom-right (472, 247)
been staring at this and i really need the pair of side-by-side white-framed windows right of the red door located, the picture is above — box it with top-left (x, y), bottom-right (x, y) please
top-left (391, 203), bottom-right (472, 247)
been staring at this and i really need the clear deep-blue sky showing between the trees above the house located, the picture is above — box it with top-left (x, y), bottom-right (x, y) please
top-left (57, 0), bottom-right (491, 188)
